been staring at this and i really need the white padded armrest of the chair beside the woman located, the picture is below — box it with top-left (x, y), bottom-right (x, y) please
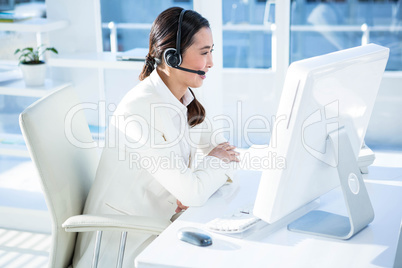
top-left (62, 214), bottom-right (170, 235)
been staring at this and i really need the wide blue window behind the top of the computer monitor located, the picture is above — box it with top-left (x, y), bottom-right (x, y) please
top-left (290, 0), bottom-right (402, 71)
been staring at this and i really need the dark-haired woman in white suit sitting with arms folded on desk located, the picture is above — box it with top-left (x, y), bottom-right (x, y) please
top-left (74, 7), bottom-right (238, 267)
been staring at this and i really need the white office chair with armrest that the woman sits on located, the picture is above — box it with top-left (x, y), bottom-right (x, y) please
top-left (19, 87), bottom-right (170, 268)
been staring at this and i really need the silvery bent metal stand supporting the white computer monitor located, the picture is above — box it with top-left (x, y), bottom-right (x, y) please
top-left (288, 128), bottom-right (374, 239)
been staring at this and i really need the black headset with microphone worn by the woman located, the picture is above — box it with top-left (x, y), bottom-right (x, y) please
top-left (163, 9), bottom-right (205, 75)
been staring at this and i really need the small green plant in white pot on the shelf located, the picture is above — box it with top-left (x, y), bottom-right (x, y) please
top-left (14, 45), bottom-right (58, 86)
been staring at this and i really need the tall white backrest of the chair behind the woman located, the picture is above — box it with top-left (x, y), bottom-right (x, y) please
top-left (20, 87), bottom-right (99, 267)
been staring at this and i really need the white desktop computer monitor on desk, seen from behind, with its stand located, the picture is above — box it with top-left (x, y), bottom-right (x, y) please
top-left (254, 44), bottom-right (389, 239)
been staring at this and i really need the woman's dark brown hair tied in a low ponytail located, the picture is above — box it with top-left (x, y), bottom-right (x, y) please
top-left (139, 7), bottom-right (210, 127)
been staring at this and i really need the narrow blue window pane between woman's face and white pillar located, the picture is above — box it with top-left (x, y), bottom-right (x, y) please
top-left (222, 0), bottom-right (274, 68)
